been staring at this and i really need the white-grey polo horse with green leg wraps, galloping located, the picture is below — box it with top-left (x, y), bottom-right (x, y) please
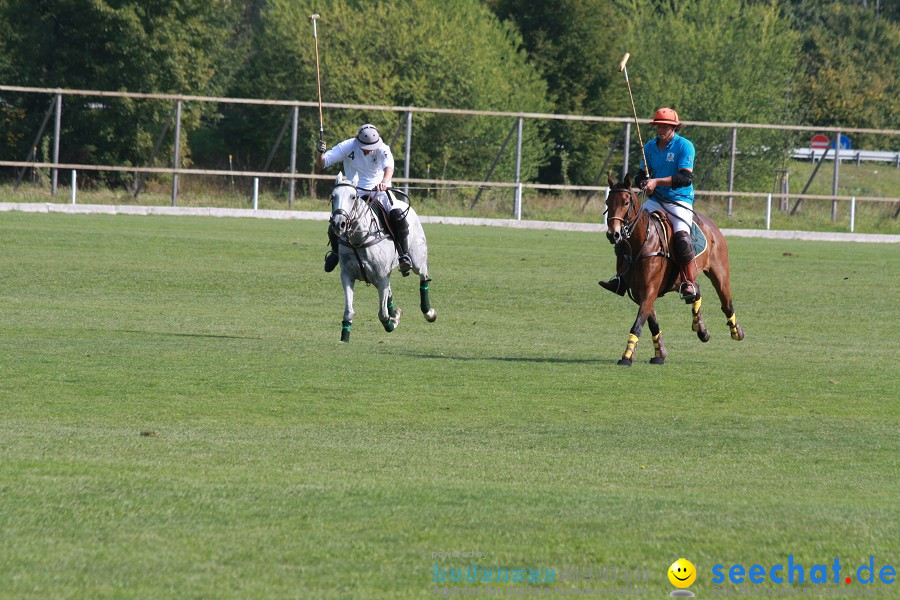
top-left (330, 173), bottom-right (437, 342)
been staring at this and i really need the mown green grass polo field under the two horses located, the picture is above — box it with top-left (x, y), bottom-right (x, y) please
top-left (0, 213), bottom-right (900, 598)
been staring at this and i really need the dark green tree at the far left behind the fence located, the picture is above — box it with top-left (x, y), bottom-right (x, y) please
top-left (0, 0), bottom-right (241, 185)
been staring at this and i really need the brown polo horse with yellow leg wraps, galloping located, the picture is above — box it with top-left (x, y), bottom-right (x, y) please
top-left (606, 175), bottom-right (744, 366)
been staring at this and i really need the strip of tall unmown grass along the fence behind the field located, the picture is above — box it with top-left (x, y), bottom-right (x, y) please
top-left (0, 160), bottom-right (900, 234)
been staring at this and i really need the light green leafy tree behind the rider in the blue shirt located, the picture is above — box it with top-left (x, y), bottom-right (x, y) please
top-left (620, 0), bottom-right (798, 189)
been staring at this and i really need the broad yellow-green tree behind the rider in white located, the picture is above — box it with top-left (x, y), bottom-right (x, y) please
top-left (211, 0), bottom-right (551, 192)
